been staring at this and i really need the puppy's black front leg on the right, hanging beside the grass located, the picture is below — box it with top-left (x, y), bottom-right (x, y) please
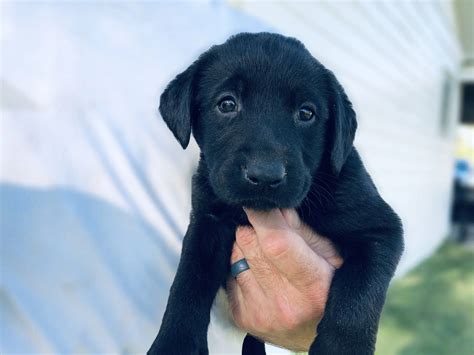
top-left (309, 234), bottom-right (403, 355)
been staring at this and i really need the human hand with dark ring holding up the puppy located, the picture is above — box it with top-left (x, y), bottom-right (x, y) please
top-left (228, 209), bottom-right (343, 351)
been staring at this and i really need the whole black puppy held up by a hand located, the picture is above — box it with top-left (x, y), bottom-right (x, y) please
top-left (148, 33), bottom-right (403, 355)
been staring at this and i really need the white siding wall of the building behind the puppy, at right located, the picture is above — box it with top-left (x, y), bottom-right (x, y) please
top-left (233, 1), bottom-right (460, 272)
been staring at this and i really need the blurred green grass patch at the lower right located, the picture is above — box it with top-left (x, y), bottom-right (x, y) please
top-left (376, 243), bottom-right (474, 355)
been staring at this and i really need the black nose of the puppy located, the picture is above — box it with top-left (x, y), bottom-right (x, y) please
top-left (243, 162), bottom-right (286, 187)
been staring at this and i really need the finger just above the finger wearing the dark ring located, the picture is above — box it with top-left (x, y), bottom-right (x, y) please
top-left (236, 227), bottom-right (281, 296)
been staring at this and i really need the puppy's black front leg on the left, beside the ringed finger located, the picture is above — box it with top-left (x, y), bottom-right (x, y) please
top-left (148, 218), bottom-right (235, 355)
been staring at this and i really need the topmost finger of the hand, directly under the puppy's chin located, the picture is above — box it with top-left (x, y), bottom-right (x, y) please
top-left (245, 210), bottom-right (328, 287)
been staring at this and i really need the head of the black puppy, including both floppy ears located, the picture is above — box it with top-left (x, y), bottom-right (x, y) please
top-left (160, 33), bottom-right (356, 209)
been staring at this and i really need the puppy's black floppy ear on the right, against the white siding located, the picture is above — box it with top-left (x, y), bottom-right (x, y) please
top-left (327, 70), bottom-right (357, 175)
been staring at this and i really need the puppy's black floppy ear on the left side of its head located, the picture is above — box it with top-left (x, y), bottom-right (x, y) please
top-left (159, 64), bottom-right (196, 149)
